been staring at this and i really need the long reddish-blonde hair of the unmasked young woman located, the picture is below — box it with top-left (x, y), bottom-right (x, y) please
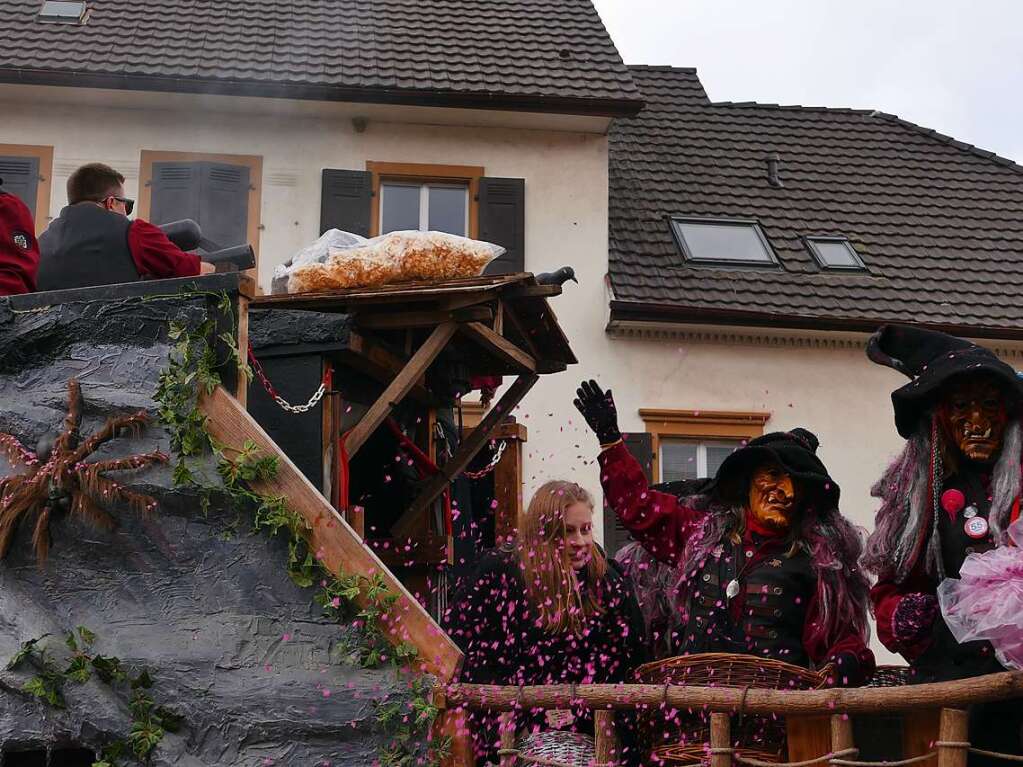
top-left (517, 480), bottom-right (608, 634)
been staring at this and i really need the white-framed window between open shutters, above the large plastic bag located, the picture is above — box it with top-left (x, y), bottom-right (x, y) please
top-left (380, 180), bottom-right (470, 236)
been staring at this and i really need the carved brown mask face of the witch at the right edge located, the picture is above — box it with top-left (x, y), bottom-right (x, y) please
top-left (939, 375), bottom-right (1009, 463)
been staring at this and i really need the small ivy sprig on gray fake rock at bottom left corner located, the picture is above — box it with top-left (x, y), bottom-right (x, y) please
top-left (7, 626), bottom-right (182, 767)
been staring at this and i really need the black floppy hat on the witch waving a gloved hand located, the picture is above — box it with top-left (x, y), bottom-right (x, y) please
top-left (658, 428), bottom-right (841, 511)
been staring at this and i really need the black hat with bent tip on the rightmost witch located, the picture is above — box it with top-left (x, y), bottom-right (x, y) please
top-left (866, 325), bottom-right (1023, 439)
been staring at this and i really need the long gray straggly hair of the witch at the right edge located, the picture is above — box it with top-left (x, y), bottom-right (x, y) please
top-left (862, 418), bottom-right (1023, 583)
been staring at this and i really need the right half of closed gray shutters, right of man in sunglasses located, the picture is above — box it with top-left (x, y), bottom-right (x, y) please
top-left (197, 163), bottom-right (250, 247)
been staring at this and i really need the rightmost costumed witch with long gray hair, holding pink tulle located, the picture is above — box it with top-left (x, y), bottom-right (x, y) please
top-left (862, 325), bottom-right (1023, 765)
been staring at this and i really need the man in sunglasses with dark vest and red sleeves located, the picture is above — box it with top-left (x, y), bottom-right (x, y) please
top-left (37, 163), bottom-right (214, 290)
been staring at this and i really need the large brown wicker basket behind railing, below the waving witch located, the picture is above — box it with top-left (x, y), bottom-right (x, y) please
top-left (636, 652), bottom-right (831, 764)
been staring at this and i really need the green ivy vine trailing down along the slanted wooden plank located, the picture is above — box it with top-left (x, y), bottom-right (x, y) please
top-left (153, 294), bottom-right (449, 767)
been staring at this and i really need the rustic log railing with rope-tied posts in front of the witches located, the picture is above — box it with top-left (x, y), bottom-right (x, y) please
top-left (437, 672), bottom-right (1023, 767)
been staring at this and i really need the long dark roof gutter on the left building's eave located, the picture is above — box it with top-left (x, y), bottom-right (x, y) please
top-left (0, 66), bottom-right (644, 118)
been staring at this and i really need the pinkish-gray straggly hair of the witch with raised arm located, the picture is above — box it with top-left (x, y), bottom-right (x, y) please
top-left (675, 495), bottom-right (870, 645)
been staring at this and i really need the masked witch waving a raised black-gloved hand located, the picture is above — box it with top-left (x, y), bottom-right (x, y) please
top-left (575, 381), bottom-right (874, 686)
